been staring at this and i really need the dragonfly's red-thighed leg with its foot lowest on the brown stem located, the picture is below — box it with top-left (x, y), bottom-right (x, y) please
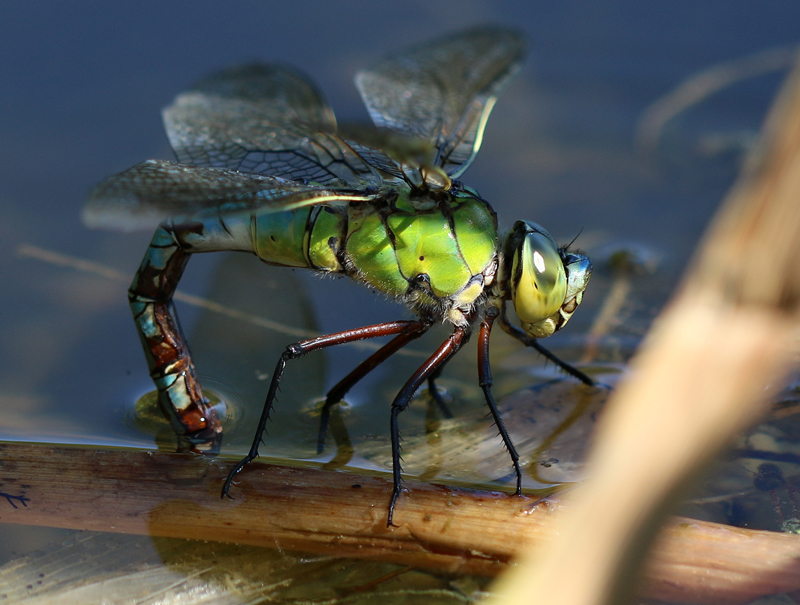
top-left (386, 328), bottom-right (469, 527)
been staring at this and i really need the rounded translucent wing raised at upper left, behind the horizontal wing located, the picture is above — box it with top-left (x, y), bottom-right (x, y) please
top-left (163, 64), bottom-right (380, 185)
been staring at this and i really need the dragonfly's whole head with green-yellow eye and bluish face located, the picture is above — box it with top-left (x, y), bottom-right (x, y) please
top-left (505, 221), bottom-right (592, 338)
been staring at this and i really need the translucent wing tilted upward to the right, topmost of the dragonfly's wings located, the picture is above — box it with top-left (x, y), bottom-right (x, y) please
top-left (356, 28), bottom-right (525, 177)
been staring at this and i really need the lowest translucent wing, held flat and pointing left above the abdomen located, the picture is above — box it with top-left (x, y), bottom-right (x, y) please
top-left (83, 160), bottom-right (377, 231)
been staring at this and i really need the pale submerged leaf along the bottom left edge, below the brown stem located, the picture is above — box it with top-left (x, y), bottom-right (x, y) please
top-left (0, 532), bottom-right (486, 605)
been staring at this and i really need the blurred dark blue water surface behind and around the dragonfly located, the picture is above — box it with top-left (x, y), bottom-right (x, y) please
top-left (0, 0), bottom-right (800, 580)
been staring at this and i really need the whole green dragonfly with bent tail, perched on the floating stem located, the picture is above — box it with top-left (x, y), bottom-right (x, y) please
top-left (83, 27), bottom-right (594, 526)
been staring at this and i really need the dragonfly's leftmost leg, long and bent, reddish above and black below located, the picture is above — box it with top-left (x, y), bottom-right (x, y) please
top-left (222, 320), bottom-right (428, 497)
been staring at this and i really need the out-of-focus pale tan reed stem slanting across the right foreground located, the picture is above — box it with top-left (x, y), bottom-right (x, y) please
top-left (494, 50), bottom-right (800, 605)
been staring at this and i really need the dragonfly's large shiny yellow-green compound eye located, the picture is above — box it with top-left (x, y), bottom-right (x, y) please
top-left (510, 221), bottom-right (567, 338)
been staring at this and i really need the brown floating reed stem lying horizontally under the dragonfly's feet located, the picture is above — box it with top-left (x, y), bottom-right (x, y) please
top-left (0, 444), bottom-right (800, 604)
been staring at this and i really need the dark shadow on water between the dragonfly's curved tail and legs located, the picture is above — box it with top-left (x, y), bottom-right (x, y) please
top-left (188, 253), bottom-right (325, 458)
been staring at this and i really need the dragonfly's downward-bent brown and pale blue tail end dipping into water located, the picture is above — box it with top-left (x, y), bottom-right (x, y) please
top-left (128, 226), bottom-right (222, 452)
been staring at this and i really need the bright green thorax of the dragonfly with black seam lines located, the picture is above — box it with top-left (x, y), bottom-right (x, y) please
top-left (343, 191), bottom-right (497, 325)
